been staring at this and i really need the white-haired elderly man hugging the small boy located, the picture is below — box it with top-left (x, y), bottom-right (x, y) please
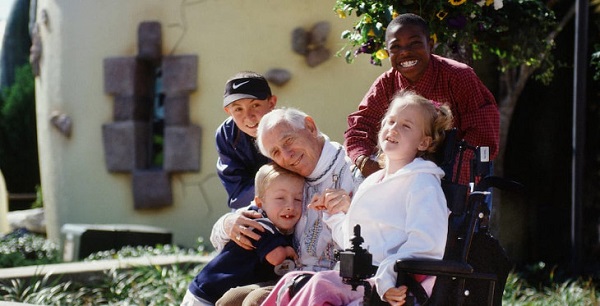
top-left (210, 108), bottom-right (360, 305)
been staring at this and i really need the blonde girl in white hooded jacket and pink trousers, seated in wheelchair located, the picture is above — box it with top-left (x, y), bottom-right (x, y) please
top-left (263, 91), bottom-right (452, 305)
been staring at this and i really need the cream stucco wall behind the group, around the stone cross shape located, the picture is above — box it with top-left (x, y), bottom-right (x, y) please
top-left (36, 0), bottom-right (387, 246)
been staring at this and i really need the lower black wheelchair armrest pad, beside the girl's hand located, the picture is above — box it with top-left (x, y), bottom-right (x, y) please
top-left (394, 259), bottom-right (474, 276)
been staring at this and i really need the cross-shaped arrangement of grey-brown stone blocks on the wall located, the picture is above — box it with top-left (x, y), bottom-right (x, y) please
top-left (102, 22), bottom-right (201, 209)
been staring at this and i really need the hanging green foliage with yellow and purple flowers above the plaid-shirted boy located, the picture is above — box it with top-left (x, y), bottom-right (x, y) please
top-left (334, 0), bottom-right (556, 82)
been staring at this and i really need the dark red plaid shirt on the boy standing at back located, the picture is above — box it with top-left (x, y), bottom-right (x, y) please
top-left (344, 54), bottom-right (500, 183)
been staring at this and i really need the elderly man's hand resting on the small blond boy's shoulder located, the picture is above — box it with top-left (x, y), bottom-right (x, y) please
top-left (224, 210), bottom-right (265, 250)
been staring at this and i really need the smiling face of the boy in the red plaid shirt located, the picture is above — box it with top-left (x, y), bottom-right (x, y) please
top-left (385, 24), bottom-right (433, 83)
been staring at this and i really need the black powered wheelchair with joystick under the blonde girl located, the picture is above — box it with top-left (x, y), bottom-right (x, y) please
top-left (337, 130), bottom-right (523, 306)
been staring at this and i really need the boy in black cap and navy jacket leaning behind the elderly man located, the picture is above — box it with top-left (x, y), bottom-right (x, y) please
top-left (216, 71), bottom-right (277, 210)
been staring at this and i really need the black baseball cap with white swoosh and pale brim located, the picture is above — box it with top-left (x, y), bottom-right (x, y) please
top-left (223, 78), bottom-right (271, 107)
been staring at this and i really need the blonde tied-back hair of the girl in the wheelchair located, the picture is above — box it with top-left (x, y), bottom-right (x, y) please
top-left (379, 90), bottom-right (454, 163)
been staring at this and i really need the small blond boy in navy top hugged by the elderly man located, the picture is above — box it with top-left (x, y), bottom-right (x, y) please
top-left (181, 163), bottom-right (304, 306)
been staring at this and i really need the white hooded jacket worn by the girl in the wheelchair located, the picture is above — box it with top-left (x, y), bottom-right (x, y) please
top-left (324, 158), bottom-right (449, 296)
